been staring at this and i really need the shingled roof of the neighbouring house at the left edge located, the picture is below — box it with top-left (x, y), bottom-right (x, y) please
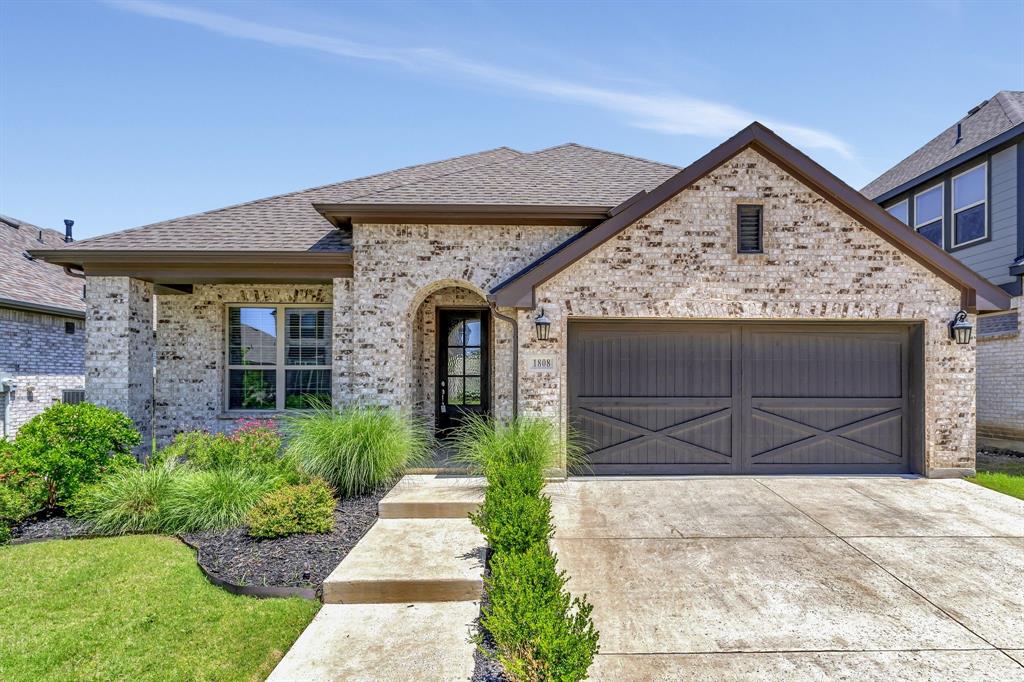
top-left (0, 215), bottom-right (85, 317)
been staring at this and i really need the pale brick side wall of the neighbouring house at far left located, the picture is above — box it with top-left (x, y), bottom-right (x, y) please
top-left (0, 308), bottom-right (85, 438)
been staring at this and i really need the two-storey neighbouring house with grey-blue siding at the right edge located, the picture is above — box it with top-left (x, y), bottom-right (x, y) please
top-left (863, 91), bottom-right (1024, 451)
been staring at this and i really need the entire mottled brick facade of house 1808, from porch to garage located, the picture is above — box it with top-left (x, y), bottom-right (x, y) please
top-left (89, 150), bottom-right (975, 474)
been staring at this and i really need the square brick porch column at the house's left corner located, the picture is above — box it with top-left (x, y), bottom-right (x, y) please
top-left (85, 276), bottom-right (154, 456)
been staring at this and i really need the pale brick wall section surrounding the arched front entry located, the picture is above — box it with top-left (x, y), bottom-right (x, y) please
top-left (351, 224), bottom-right (578, 417)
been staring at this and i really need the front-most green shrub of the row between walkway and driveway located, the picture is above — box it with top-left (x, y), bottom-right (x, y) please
top-left (480, 544), bottom-right (598, 682)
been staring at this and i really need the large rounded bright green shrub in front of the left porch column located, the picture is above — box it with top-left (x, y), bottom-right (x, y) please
top-left (14, 402), bottom-right (141, 507)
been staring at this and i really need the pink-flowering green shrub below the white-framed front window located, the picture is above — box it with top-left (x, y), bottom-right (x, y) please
top-left (150, 419), bottom-right (299, 483)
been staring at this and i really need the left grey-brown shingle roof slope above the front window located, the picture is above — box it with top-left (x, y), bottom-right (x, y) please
top-left (58, 147), bottom-right (521, 251)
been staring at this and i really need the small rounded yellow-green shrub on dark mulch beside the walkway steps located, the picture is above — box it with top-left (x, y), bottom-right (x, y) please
top-left (247, 478), bottom-right (335, 538)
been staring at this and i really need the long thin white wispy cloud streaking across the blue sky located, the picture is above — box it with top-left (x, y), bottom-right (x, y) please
top-left (108, 0), bottom-right (854, 159)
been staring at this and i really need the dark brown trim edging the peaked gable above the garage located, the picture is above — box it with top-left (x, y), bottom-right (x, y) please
top-left (488, 122), bottom-right (1010, 310)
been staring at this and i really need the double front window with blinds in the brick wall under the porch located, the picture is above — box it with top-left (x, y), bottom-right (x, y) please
top-left (224, 303), bottom-right (333, 412)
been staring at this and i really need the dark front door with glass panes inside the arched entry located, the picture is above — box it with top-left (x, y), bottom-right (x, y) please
top-left (436, 310), bottom-right (489, 435)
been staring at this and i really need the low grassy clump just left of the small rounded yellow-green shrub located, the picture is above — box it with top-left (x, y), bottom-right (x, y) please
top-left (160, 467), bottom-right (276, 532)
